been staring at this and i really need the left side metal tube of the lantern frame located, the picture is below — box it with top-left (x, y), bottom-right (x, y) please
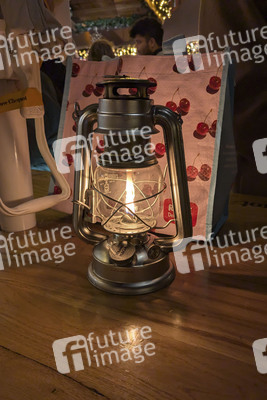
top-left (73, 104), bottom-right (107, 244)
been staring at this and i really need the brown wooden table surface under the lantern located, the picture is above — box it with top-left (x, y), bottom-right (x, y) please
top-left (0, 173), bottom-right (267, 400)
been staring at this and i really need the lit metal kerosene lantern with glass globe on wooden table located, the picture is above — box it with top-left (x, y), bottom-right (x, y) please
top-left (73, 76), bottom-right (192, 295)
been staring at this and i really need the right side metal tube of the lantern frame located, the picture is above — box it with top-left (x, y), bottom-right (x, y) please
top-left (152, 106), bottom-right (192, 251)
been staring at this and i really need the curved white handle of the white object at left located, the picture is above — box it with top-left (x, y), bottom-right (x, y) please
top-left (0, 117), bottom-right (71, 216)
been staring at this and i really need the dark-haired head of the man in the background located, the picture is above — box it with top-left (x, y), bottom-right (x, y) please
top-left (130, 17), bottom-right (163, 56)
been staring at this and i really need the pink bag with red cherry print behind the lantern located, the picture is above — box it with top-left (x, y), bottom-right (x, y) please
top-left (52, 55), bottom-right (235, 237)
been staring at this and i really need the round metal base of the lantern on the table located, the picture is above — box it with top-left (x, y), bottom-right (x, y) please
top-left (88, 242), bottom-right (175, 295)
